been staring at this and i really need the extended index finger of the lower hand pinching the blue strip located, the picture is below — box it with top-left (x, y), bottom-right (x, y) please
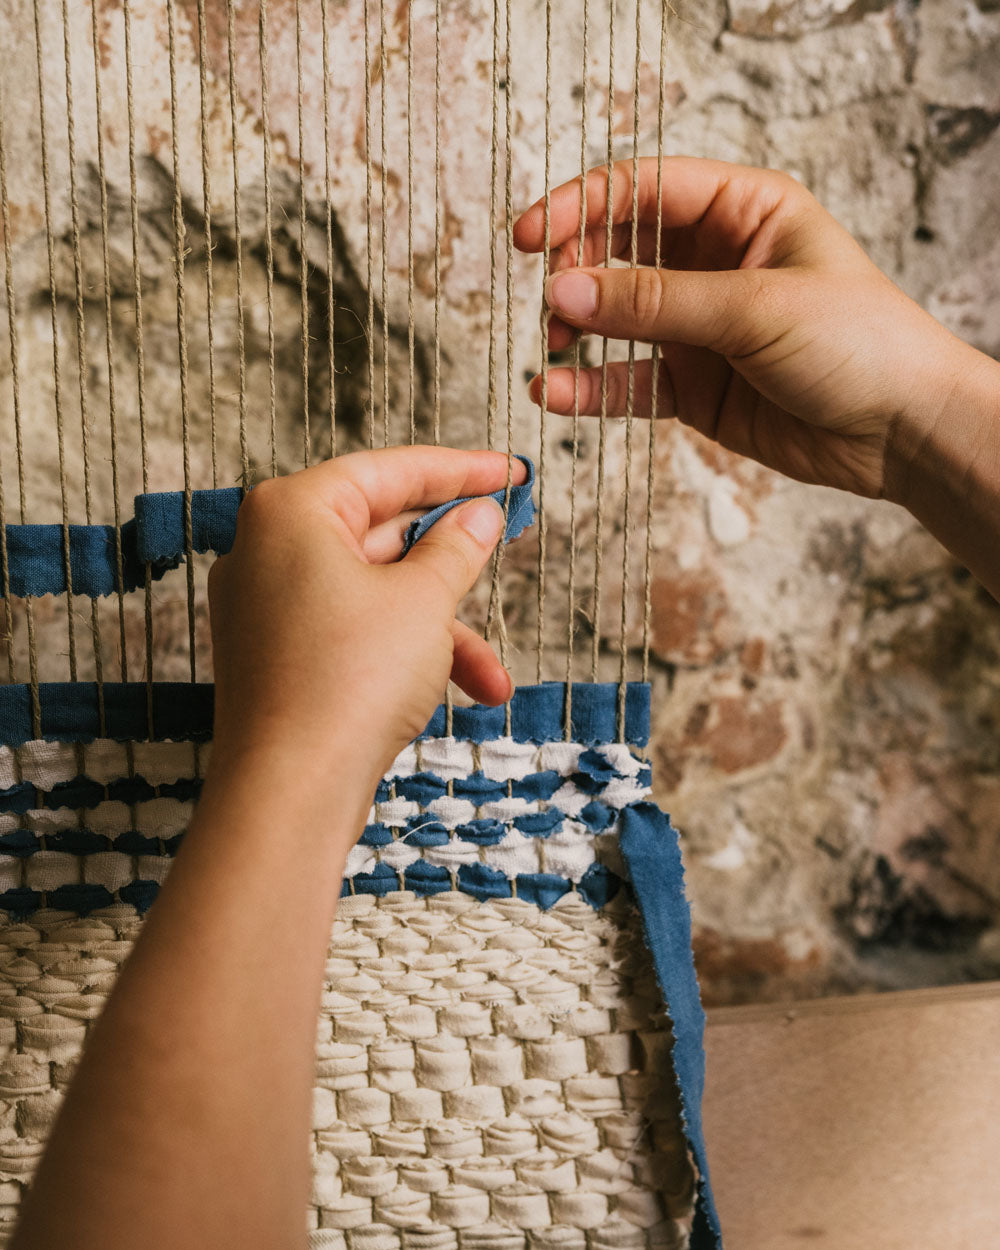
top-left (288, 446), bottom-right (528, 541)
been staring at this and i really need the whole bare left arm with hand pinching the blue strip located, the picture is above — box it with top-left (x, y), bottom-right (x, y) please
top-left (13, 448), bottom-right (520, 1250)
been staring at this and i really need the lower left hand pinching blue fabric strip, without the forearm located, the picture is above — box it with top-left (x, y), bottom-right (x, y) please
top-left (209, 448), bottom-right (525, 786)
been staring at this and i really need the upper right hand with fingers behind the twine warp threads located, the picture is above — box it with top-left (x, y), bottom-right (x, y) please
top-left (514, 158), bottom-right (985, 503)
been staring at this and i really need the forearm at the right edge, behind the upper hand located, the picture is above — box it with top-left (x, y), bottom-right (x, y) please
top-left (886, 344), bottom-right (1000, 599)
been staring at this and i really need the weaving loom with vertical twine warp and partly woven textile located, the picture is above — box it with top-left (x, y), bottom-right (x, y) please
top-left (0, 0), bottom-right (719, 1250)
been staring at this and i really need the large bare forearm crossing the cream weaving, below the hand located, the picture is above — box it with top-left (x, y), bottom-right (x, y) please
top-left (14, 735), bottom-right (374, 1250)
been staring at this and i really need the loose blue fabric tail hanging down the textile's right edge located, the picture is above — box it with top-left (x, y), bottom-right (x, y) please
top-left (620, 803), bottom-right (723, 1250)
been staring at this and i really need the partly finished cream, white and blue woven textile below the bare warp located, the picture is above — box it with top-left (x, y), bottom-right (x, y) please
top-left (0, 685), bottom-right (715, 1250)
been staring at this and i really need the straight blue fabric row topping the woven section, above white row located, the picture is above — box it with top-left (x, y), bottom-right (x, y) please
top-left (0, 681), bottom-right (650, 740)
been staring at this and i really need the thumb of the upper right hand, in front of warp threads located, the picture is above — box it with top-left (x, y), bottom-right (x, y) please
top-left (545, 269), bottom-right (789, 355)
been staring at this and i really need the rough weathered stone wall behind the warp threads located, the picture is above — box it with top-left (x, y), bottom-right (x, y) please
top-left (0, 0), bottom-right (1000, 1001)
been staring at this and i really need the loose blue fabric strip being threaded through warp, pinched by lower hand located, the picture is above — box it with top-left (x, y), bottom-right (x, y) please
top-left (6, 456), bottom-right (535, 599)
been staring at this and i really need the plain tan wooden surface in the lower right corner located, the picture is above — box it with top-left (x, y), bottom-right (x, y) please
top-left (705, 983), bottom-right (1000, 1250)
